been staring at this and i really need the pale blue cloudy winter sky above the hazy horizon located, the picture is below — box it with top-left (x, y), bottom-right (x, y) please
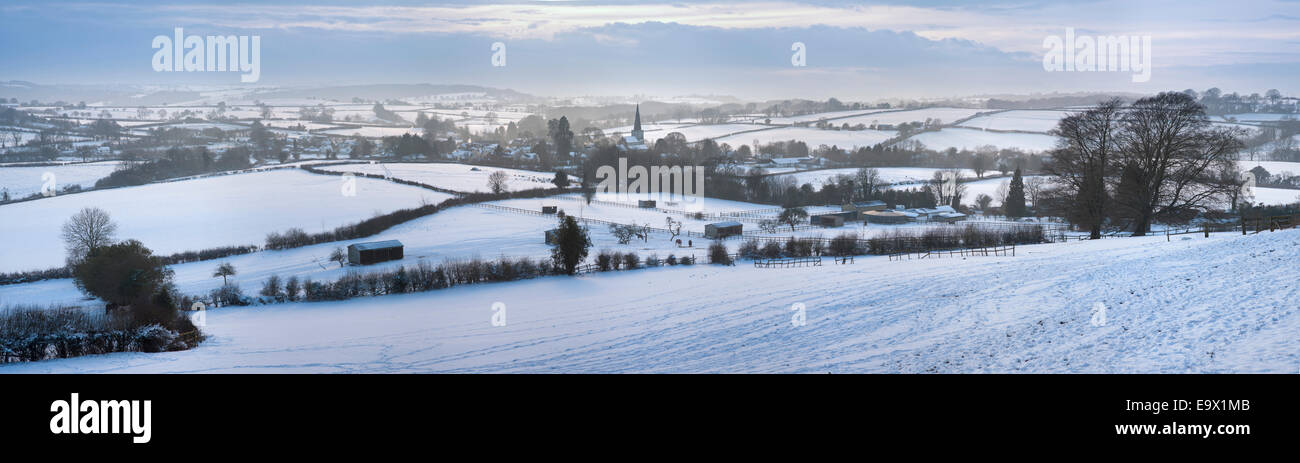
top-left (0, 0), bottom-right (1300, 100)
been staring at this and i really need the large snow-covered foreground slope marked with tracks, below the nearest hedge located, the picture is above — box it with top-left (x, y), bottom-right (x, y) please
top-left (0, 230), bottom-right (1300, 373)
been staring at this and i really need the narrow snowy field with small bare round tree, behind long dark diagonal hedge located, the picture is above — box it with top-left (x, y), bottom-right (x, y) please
top-left (321, 163), bottom-right (572, 192)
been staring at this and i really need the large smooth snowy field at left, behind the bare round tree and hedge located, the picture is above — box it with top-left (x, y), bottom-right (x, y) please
top-left (0, 169), bottom-right (450, 272)
